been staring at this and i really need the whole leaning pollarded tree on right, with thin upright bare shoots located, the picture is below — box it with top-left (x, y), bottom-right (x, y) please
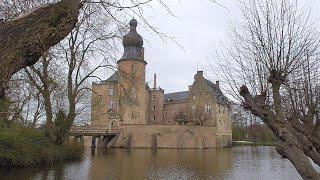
top-left (215, 0), bottom-right (320, 179)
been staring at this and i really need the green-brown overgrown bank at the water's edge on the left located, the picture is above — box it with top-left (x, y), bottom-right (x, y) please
top-left (0, 128), bottom-right (83, 167)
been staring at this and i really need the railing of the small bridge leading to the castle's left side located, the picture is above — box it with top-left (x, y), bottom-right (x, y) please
top-left (69, 126), bottom-right (118, 135)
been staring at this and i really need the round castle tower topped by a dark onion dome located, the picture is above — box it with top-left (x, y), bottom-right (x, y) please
top-left (118, 19), bottom-right (149, 124)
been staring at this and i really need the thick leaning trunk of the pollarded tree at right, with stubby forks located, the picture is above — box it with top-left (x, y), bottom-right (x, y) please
top-left (240, 84), bottom-right (320, 180)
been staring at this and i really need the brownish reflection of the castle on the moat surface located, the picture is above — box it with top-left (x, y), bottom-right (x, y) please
top-left (89, 149), bottom-right (233, 179)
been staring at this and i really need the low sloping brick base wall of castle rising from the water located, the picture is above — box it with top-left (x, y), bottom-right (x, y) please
top-left (108, 125), bottom-right (231, 149)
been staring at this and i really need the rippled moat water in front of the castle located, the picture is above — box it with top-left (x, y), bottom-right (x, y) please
top-left (0, 146), bottom-right (301, 180)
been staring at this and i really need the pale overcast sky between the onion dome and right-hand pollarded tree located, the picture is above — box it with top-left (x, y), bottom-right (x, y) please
top-left (110, 0), bottom-right (320, 93)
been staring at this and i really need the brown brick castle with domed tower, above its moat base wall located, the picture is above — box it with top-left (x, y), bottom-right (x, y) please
top-left (91, 19), bottom-right (231, 148)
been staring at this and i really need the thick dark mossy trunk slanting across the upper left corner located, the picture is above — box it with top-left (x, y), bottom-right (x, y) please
top-left (0, 0), bottom-right (81, 102)
